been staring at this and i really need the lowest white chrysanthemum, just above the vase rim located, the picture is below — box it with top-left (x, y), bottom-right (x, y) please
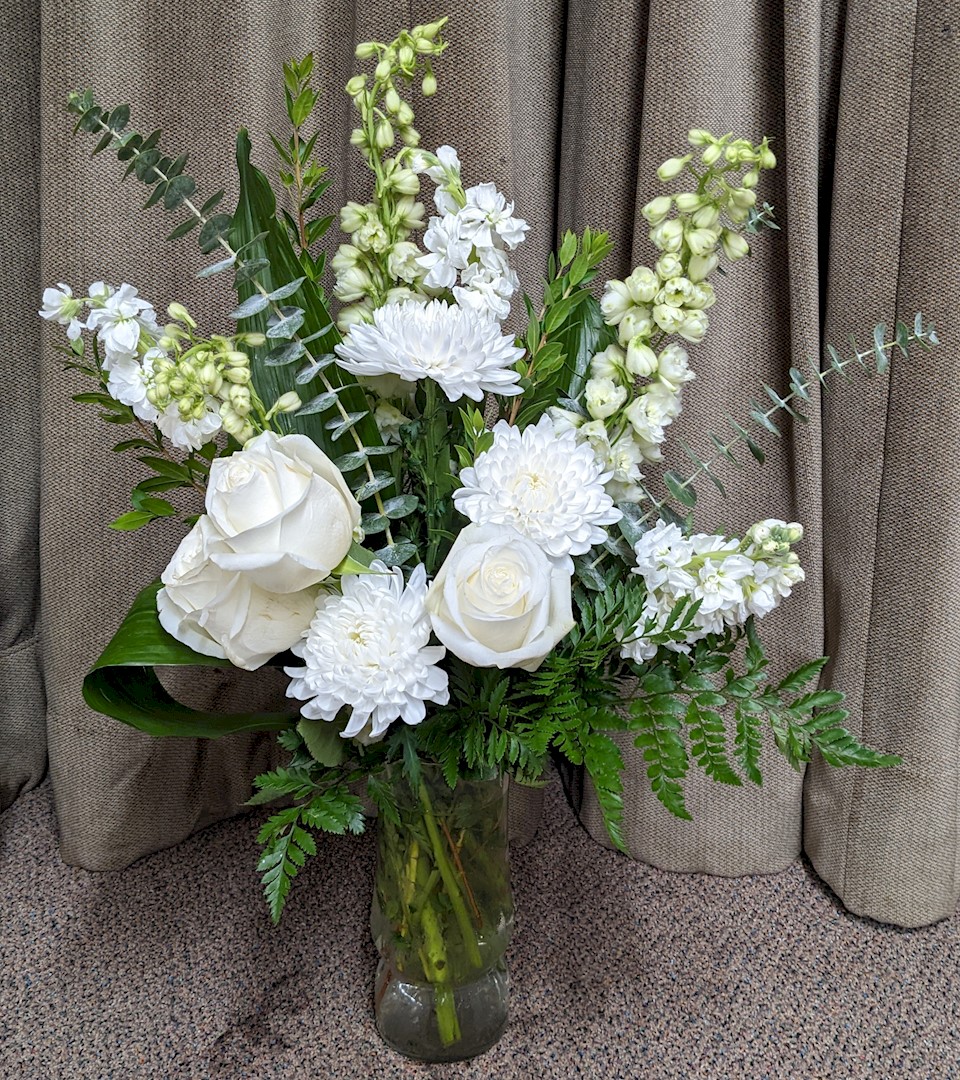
top-left (284, 562), bottom-right (449, 741)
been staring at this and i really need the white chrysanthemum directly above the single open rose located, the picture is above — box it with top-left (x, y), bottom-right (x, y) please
top-left (454, 415), bottom-right (623, 558)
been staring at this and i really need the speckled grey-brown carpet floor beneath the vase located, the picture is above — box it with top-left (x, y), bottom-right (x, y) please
top-left (0, 784), bottom-right (960, 1080)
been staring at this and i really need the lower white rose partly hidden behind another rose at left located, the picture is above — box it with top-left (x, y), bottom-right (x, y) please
top-left (157, 514), bottom-right (316, 671)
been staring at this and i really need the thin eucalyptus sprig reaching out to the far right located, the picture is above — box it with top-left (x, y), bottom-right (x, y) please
top-left (637, 312), bottom-right (938, 524)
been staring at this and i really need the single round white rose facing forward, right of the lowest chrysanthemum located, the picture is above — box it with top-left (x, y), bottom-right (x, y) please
top-left (427, 524), bottom-right (573, 672)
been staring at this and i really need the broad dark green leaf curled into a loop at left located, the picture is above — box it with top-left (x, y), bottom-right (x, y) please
top-left (83, 581), bottom-right (297, 739)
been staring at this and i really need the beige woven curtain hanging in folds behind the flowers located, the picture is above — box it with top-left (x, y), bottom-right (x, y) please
top-left (0, 0), bottom-right (960, 926)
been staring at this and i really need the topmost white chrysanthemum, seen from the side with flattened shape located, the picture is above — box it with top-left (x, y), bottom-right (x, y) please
top-left (336, 300), bottom-right (523, 402)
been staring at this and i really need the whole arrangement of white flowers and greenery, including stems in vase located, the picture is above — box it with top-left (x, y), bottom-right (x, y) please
top-left (46, 19), bottom-right (936, 1062)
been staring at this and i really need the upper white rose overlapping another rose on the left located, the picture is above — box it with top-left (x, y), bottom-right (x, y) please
top-left (206, 431), bottom-right (360, 593)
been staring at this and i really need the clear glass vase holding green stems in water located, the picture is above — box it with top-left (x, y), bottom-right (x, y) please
top-left (370, 765), bottom-right (513, 1062)
